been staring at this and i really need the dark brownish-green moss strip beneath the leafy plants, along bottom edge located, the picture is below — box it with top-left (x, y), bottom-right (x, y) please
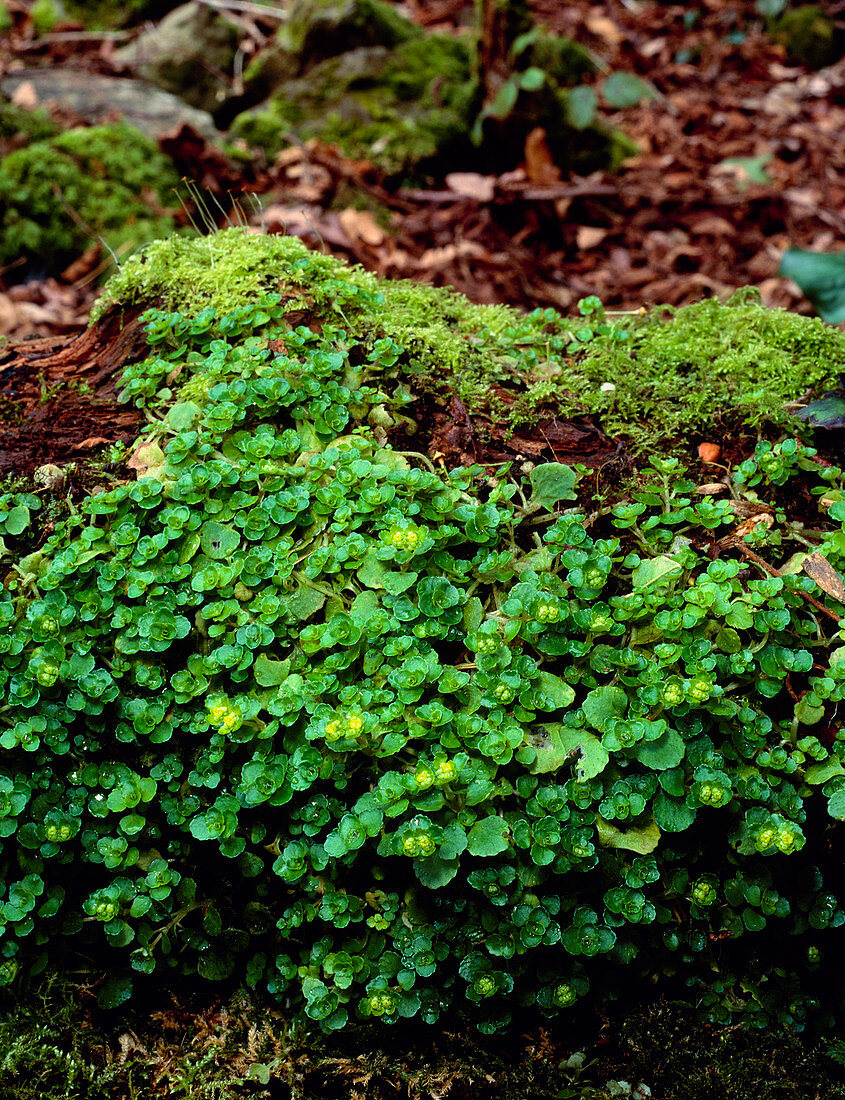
top-left (0, 979), bottom-right (842, 1100)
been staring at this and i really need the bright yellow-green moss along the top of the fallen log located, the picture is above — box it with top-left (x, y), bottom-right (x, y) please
top-left (92, 229), bottom-right (845, 452)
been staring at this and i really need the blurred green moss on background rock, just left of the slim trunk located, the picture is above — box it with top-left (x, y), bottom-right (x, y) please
top-left (232, 34), bottom-right (474, 172)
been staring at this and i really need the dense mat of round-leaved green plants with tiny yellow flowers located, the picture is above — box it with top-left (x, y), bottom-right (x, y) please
top-left (0, 234), bottom-right (845, 1033)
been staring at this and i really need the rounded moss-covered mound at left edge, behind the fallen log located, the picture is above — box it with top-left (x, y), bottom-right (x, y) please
top-left (0, 124), bottom-right (178, 268)
